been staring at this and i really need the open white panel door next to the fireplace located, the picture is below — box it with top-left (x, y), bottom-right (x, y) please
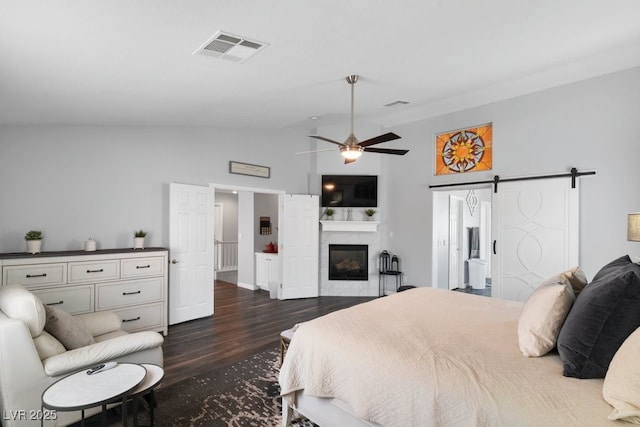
top-left (279, 194), bottom-right (320, 299)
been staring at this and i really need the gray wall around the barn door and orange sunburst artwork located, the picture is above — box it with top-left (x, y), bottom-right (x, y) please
top-left (387, 68), bottom-right (640, 286)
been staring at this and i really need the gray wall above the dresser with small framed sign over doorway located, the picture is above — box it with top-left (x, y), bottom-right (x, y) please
top-left (0, 127), bottom-right (308, 252)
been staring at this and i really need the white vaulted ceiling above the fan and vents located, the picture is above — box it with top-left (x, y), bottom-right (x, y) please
top-left (0, 0), bottom-right (640, 130)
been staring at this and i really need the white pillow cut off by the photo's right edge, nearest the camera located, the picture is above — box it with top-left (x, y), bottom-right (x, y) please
top-left (602, 328), bottom-right (640, 424)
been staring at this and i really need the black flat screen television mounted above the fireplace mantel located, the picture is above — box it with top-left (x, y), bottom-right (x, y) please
top-left (322, 175), bottom-right (378, 208)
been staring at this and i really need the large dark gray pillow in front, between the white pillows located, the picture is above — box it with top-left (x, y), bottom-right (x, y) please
top-left (557, 257), bottom-right (640, 378)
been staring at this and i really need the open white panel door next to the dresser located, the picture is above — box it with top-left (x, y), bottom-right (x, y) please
top-left (169, 183), bottom-right (215, 325)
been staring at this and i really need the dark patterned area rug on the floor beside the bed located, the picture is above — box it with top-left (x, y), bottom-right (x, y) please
top-left (79, 349), bottom-right (315, 427)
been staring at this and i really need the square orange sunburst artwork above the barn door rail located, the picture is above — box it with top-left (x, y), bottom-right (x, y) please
top-left (436, 123), bottom-right (493, 175)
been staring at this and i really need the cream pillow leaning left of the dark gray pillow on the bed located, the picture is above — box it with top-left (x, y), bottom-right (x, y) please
top-left (518, 273), bottom-right (576, 357)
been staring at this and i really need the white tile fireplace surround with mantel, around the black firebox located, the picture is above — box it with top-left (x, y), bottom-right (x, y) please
top-left (320, 221), bottom-right (380, 297)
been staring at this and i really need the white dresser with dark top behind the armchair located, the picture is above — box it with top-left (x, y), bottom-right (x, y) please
top-left (0, 248), bottom-right (169, 335)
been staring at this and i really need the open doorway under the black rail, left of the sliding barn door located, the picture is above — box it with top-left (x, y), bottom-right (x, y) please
top-left (433, 187), bottom-right (491, 296)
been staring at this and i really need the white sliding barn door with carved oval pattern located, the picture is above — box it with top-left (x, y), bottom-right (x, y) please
top-left (491, 178), bottom-right (579, 301)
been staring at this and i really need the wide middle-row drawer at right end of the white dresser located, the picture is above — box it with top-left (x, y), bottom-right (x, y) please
top-left (96, 277), bottom-right (164, 310)
